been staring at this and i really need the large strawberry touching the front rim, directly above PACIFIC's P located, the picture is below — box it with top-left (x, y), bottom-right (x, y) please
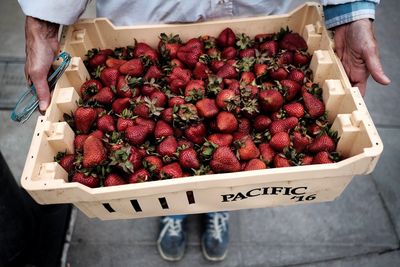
top-left (210, 146), bottom-right (241, 173)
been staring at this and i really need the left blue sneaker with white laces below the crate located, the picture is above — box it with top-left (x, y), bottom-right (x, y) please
top-left (157, 216), bottom-right (187, 261)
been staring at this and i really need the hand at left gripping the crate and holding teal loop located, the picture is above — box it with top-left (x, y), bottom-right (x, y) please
top-left (25, 16), bottom-right (59, 111)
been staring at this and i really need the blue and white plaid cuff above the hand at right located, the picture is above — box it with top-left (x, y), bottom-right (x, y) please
top-left (321, 0), bottom-right (379, 29)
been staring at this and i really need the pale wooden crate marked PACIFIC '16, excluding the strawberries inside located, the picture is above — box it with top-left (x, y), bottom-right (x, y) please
top-left (21, 4), bottom-right (383, 220)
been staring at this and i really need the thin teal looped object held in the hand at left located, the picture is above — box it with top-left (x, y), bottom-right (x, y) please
top-left (11, 52), bottom-right (71, 123)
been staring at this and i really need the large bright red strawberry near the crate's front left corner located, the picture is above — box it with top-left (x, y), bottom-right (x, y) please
top-left (83, 136), bottom-right (107, 168)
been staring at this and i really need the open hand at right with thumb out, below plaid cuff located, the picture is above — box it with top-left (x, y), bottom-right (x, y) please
top-left (334, 19), bottom-right (390, 96)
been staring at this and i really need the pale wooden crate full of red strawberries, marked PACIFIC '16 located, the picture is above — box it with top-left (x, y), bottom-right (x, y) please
top-left (22, 4), bottom-right (382, 219)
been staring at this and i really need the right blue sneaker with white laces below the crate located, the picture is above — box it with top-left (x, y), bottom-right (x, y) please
top-left (201, 212), bottom-right (229, 261)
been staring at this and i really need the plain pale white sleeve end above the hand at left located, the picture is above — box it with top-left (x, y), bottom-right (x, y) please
top-left (18, 0), bottom-right (89, 25)
